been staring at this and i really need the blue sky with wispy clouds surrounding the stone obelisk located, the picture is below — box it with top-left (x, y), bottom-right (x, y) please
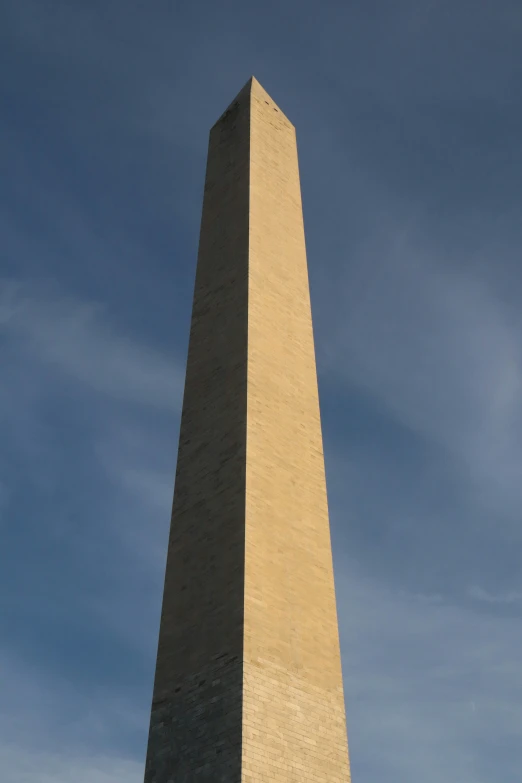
top-left (0, 0), bottom-right (522, 783)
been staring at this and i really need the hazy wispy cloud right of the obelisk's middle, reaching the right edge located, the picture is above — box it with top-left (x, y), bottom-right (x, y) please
top-left (323, 225), bottom-right (522, 513)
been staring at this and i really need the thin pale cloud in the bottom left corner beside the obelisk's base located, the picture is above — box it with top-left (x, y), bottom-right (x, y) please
top-left (0, 650), bottom-right (147, 783)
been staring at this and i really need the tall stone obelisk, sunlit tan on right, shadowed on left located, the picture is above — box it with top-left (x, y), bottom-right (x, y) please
top-left (145, 78), bottom-right (350, 783)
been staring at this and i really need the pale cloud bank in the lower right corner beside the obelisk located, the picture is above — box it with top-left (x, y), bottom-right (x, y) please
top-left (336, 558), bottom-right (522, 783)
